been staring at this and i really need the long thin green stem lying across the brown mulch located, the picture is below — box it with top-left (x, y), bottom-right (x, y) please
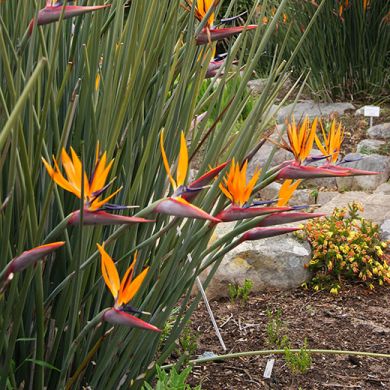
top-left (161, 349), bottom-right (390, 370)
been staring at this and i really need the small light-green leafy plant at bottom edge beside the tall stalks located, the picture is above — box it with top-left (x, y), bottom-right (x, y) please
top-left (142, 366), bottom-right (201, 390)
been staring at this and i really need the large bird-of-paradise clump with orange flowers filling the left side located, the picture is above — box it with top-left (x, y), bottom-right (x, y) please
top-left (0, 0), bottom-right (378, 389)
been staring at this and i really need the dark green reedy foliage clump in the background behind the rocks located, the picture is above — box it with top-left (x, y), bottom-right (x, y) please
top-left (281, 0), bottom-right (390, 100)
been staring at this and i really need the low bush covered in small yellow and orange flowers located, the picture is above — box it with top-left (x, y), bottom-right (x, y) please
top-left (304, 202), bottom-right (390, 294)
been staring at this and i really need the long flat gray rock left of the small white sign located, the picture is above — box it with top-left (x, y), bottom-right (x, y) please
top-left (277, 100), bottom-right (355, 123)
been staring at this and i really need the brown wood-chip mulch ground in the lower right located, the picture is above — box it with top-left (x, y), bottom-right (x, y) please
top-left (188, 285), bottom-right (390, 390)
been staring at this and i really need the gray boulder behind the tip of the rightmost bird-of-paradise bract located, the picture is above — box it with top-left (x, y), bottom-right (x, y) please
top-left (336, 153), bottom-right (390, 191)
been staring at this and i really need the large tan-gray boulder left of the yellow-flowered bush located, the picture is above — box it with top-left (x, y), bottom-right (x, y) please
top-left (201, 224), bottom-right (311, 299)
